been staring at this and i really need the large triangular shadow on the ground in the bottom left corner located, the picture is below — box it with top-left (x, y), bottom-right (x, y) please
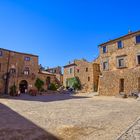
top-left (0, 103), bottom-right (59, 140)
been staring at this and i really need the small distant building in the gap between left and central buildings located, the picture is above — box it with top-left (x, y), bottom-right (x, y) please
top-left (46, 66), bottom-right (63, 85)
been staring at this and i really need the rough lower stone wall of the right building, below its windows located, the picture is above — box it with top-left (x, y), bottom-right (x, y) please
top-left (99, 67), bottom-right (140, 96)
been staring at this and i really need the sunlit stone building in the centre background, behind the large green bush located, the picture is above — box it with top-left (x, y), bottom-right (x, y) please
top-left (63, 59), bottom-right (100, 92)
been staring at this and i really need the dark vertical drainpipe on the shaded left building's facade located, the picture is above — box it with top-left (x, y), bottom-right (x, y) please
top-left (5, 51), bottom-right (10, 95)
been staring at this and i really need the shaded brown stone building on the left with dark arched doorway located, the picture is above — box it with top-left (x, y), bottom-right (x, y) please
top-left (0, 48), bottom-right (56, 93)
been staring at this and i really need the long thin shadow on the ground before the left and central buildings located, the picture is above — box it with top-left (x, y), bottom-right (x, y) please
top-left (3, 94), bottom-right (90, 102)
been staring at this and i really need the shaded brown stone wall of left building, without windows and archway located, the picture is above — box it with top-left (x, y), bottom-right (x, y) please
top-left (0, 49), bottom-right (56, 93)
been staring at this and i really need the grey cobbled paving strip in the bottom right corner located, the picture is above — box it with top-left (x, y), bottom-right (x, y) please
top-left (118, 119), bottom-right (140, 140)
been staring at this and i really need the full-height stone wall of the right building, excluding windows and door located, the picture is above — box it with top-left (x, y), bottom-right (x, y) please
top-left (99, 33), bottom-right (140, 95)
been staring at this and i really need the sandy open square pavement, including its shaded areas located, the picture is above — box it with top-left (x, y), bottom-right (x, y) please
top-left (0, 94), bottom-right (140, 140)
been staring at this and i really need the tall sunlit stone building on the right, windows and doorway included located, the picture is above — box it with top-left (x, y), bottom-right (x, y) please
top-left (99, 31), bottom-right (140, 95)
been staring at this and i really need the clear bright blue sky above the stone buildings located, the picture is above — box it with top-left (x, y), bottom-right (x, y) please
top-left (0, 0), bottom-right (140, 67)
